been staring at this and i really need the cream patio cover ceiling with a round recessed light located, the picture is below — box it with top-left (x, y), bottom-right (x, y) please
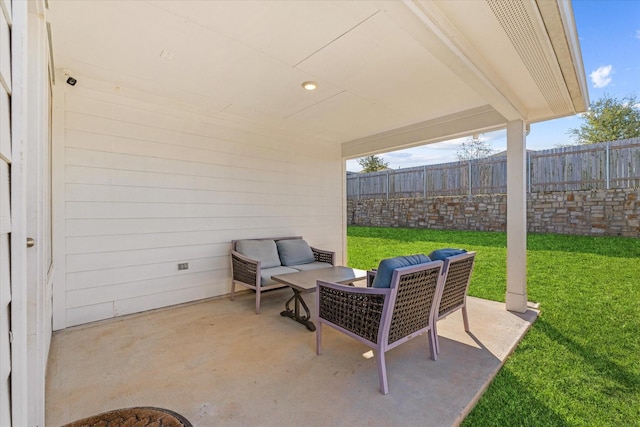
top-left (49, 0), bottom-right (588, 157)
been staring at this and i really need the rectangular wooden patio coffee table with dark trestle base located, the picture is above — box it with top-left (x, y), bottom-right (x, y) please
top-left (271, 266), bottom-right (367, 331)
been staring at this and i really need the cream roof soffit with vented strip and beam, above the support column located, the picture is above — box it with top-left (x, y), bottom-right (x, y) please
top-left (405, 0), bottom-right (585, 122)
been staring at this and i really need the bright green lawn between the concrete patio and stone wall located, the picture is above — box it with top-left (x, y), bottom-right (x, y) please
top-left (347, 227), bottom-right (640, 426)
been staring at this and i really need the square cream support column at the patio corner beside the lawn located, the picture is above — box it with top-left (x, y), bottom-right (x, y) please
top-left (506, 120), bottom-right (527, 313)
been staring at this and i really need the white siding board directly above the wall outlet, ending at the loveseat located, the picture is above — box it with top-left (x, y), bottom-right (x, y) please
top-left (66, 242), bottom-right (231, 274)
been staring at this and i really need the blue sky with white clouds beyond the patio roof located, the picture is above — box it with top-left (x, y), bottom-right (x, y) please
top-left (347, 0), bottom-right (640, 172)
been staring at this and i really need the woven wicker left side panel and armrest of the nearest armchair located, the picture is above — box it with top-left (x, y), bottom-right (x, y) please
top-left (316, 280), bottom-right (391, 343)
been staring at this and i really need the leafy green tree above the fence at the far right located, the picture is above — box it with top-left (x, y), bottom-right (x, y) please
top-left (568, 94), bottom-right (640, 144)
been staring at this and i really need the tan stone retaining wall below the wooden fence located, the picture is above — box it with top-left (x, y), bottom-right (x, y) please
top-left (347, 188), bottom-right (640, 237)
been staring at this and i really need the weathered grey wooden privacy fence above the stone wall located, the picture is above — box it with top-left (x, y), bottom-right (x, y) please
top-left (347, 138), bottom-right (640, 199)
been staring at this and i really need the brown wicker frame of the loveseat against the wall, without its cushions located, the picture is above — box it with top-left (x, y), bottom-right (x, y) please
top-left (231, 236), bottom-right (335, 314)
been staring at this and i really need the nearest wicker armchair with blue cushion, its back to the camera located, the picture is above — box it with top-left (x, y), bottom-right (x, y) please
top-left (316, 255), bottom-right (444, 394)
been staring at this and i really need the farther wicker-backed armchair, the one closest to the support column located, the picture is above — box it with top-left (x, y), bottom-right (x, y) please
top-left (432, 252), bottom-right (476, 354)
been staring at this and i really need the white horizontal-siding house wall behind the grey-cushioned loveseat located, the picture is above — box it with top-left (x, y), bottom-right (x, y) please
top-left (54, 76), bottom-right (344, 328)
